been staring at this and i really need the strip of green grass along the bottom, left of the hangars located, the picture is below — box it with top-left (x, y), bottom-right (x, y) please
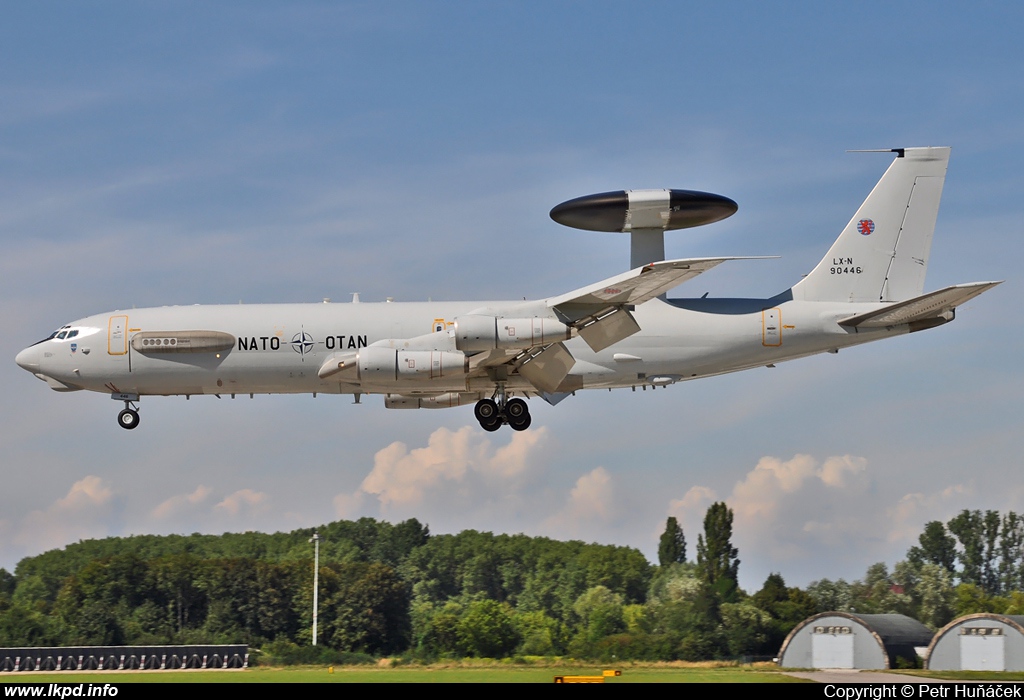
top-left (0, 663), bottom-right (805, 684)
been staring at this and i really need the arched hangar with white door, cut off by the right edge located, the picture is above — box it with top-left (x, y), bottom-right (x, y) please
top-left (925, 613), bottom-right (1024, 670)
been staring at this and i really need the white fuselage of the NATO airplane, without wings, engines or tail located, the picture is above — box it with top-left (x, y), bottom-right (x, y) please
top-left (17, 295), bottom-right (908, 396)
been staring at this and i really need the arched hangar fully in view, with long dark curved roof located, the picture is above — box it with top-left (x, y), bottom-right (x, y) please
top-left (778, 612), bottom-right (932, 668)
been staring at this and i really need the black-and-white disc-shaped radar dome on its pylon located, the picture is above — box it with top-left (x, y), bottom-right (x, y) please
top-left (551, 189), bottom-right (739, 269)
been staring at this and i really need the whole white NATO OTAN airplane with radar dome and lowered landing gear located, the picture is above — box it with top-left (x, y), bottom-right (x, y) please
top-left (16, 147), bottom-right (1000, 431)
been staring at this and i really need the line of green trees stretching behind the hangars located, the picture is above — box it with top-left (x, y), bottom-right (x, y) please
top-left (0, 502), bottom-right (1024, 660)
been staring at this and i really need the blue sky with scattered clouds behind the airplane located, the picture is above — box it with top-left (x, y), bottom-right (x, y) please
top-left (0, 2), bottom-right (1024, 588)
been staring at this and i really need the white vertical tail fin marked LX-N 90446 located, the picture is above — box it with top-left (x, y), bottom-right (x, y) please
top-left (793, 147), bottom-right (949, 302)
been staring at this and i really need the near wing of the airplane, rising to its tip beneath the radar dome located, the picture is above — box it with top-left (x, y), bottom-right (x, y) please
top-left (548, 257), bottom-right (763, 319)
